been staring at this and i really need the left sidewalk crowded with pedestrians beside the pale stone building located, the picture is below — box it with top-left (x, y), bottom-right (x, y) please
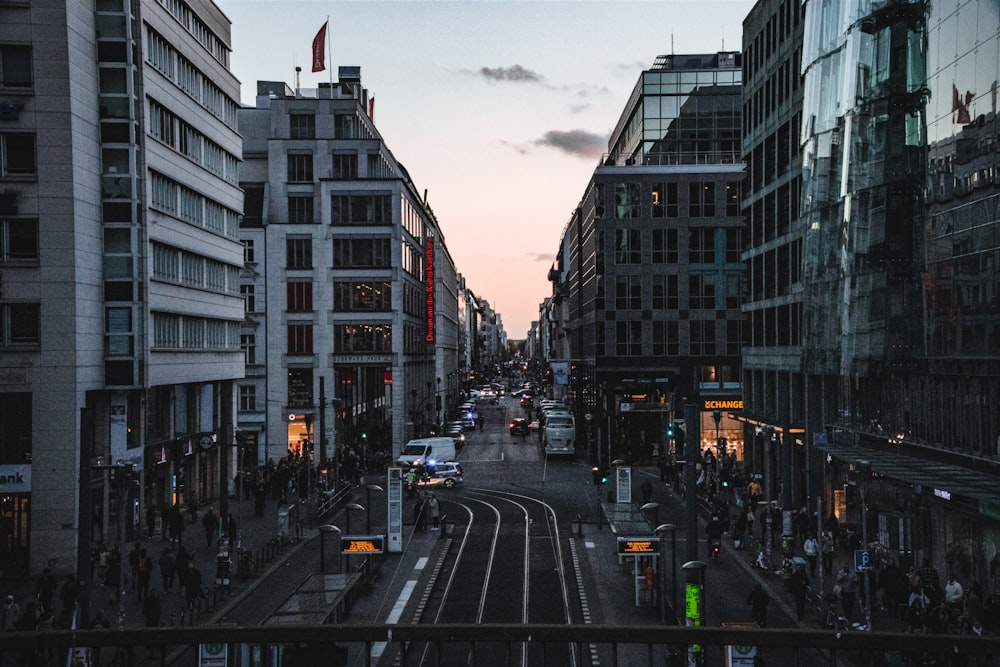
top-left (0, 498), bottom-right (308, 628)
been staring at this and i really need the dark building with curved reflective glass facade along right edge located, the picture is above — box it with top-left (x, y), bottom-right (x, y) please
top-left (744, 0), bottom-right (1000, 583)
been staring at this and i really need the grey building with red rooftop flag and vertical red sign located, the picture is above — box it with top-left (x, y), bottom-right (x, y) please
top-left (238, 67), bottom-right (458, 475)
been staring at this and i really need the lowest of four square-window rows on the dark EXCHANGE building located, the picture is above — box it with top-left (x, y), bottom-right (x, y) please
top-left (595, 320), bottom-right (743, 357)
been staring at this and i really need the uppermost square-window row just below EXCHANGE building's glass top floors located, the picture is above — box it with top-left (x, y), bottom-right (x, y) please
top-left (597, 181), bottom-right (740, 220)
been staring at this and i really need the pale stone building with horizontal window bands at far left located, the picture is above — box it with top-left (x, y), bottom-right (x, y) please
top-left (0, 0), bottom-right (243, 571)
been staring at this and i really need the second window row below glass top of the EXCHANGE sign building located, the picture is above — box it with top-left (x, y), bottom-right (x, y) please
top-left (595, 227), bottom-right (744, 264)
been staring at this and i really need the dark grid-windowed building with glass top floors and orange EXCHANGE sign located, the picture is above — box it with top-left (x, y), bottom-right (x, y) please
top-left (544, 52), bottom-right (744, 464)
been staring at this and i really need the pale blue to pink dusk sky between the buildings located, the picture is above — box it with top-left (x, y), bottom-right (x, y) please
top-left (215, 0), bottom-right (754, 339)
